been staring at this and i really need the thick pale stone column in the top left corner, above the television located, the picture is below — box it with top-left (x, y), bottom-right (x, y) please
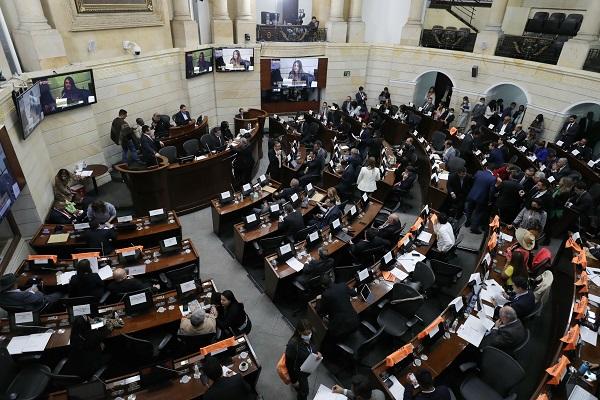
top-left (13, 0), bottom-right (69, 71)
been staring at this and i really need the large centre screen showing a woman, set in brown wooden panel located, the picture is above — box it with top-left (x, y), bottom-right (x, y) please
top-left (271, 58), bottom-right (319, 88)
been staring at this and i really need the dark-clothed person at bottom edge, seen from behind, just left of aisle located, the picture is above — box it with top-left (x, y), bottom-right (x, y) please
top-left (202, 356), bottom-right (256, 400)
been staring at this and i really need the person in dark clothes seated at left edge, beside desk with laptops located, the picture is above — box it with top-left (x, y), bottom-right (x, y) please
top-left (0, 273), bottom-right (61, 312)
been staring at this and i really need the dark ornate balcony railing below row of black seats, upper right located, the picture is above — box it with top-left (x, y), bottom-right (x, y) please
top-left (495, 35), bottom-right (564, 65)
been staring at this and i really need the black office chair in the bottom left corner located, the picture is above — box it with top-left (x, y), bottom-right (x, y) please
top-left (0, 349), bottom-right (50, 400)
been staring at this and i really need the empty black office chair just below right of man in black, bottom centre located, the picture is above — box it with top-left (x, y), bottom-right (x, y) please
top-left (335, 321), bottom-right (384, 369)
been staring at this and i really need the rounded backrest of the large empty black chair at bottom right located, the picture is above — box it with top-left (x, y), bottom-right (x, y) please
top-left (479, 347), bottom-right (525, 397)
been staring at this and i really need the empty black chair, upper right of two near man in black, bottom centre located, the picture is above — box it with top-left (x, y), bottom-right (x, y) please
top-left (377, 283), bottom-right (425, 338)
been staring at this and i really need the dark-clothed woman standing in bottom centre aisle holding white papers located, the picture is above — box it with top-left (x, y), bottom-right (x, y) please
top-left (285, 319), bottom-right (321, 400)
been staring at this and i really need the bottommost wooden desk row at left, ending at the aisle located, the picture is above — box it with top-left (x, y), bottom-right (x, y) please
top-left (48, 335), bottom-right (262, 400)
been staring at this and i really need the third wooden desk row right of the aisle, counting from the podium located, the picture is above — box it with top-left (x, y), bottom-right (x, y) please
top-left (264, 198), bottom-right (383, 300)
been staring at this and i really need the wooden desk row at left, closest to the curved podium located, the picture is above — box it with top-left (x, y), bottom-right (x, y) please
top-left (29, 214), bottom-right (181, 258)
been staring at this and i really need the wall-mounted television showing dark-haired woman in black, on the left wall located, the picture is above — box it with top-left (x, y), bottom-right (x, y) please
top-left (32, 69), bottom-right (96, 115)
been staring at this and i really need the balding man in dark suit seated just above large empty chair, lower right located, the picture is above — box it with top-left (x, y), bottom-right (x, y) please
top-left (479, 306), bottom-right (527, 354)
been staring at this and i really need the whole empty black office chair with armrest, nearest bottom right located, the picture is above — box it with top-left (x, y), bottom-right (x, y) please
top-left (459, 347), bottom-right (525, 400)
